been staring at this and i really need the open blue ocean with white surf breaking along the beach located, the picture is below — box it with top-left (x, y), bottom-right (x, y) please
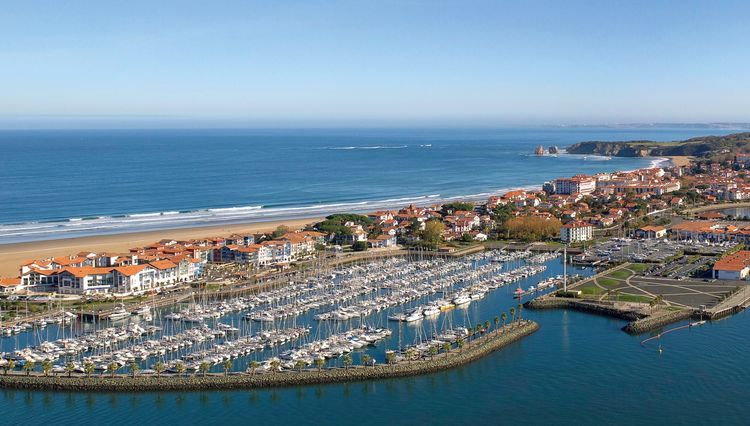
top-left (0, 128), bottom-right (728, 244)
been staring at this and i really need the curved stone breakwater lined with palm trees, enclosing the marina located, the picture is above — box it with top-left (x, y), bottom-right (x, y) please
top-left (0, 320), bottom-right (539, 392)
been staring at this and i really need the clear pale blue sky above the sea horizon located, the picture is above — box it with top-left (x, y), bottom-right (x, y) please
top-left (0, 0), bottom-right (750, 127)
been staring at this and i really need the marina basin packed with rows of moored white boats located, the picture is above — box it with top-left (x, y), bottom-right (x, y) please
top-left (0, 250), bottom-right (588, 375)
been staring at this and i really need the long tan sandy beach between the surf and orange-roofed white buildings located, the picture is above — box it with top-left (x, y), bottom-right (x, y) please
top-left (0, 218), bottom-right (322, 277)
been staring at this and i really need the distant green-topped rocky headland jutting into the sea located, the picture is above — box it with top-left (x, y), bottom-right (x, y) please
top-left (567, 132), bottom-right (750, 157)
